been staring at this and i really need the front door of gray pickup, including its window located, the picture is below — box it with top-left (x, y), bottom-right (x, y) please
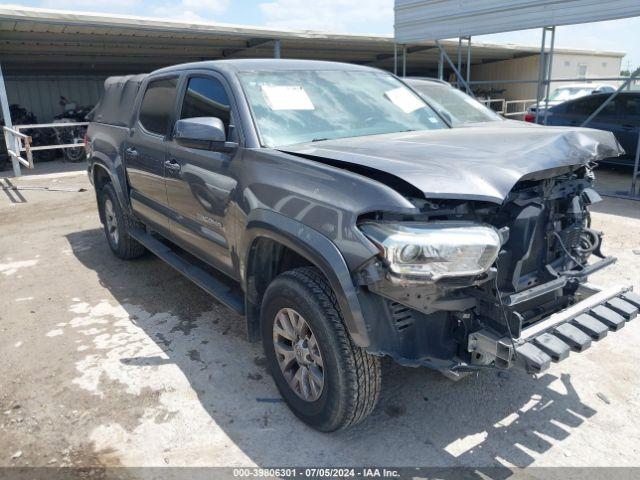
top-left (167, 72), bottom-right (239, 278)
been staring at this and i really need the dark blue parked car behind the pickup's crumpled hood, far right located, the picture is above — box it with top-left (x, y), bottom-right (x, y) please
top-left (538, 92), bottom-right (640, 165)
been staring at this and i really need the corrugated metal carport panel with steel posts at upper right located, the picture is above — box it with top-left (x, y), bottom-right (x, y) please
top-left (394, 0), bottom-right (640, 197)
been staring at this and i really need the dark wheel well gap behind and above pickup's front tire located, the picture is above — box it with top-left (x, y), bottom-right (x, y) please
top-left (246, 237), bottom-right (315, 341)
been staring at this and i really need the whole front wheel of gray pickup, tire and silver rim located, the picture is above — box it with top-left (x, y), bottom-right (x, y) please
top-left (261, 267), bottom-right (381, 432)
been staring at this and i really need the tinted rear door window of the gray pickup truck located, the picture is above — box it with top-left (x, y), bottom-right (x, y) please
top-left (138, 77), bottom-right (178, 135)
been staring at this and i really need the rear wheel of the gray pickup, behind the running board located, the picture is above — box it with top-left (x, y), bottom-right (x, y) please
top-left (99, 183), bottom-right (146, 260)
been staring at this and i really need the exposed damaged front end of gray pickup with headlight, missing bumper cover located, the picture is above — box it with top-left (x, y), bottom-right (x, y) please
top-left (358, 165), bottom-right (640, 375)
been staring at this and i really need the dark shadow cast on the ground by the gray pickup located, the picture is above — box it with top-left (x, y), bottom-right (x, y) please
top-left (67, 229), bottom-right (596, 478)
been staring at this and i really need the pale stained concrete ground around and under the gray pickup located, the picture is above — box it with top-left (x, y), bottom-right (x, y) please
top-left (0, 162), bottom-right (640, 476)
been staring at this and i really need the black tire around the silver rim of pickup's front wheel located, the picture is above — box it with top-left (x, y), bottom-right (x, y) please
top-left (261, 267), bottom-right (381, 432)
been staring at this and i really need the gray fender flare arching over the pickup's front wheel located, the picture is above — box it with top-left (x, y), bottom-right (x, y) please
top-left (243, 209), bottom-right (370, 348)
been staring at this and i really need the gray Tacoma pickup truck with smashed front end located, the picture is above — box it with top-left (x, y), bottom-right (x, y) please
top-left (86, 60), bottom-right (640, 431)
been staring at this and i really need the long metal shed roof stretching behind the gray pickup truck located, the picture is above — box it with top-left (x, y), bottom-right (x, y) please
top-left (0, 6), bottom-right (623, 76)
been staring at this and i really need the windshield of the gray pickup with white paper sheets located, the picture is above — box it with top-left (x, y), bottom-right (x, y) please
top-left (239, 70), bottom-right (447, 147)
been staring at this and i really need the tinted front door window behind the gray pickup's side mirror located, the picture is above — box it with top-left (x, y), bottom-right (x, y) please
top-left (180, 77), bottom-right (231, 132)
